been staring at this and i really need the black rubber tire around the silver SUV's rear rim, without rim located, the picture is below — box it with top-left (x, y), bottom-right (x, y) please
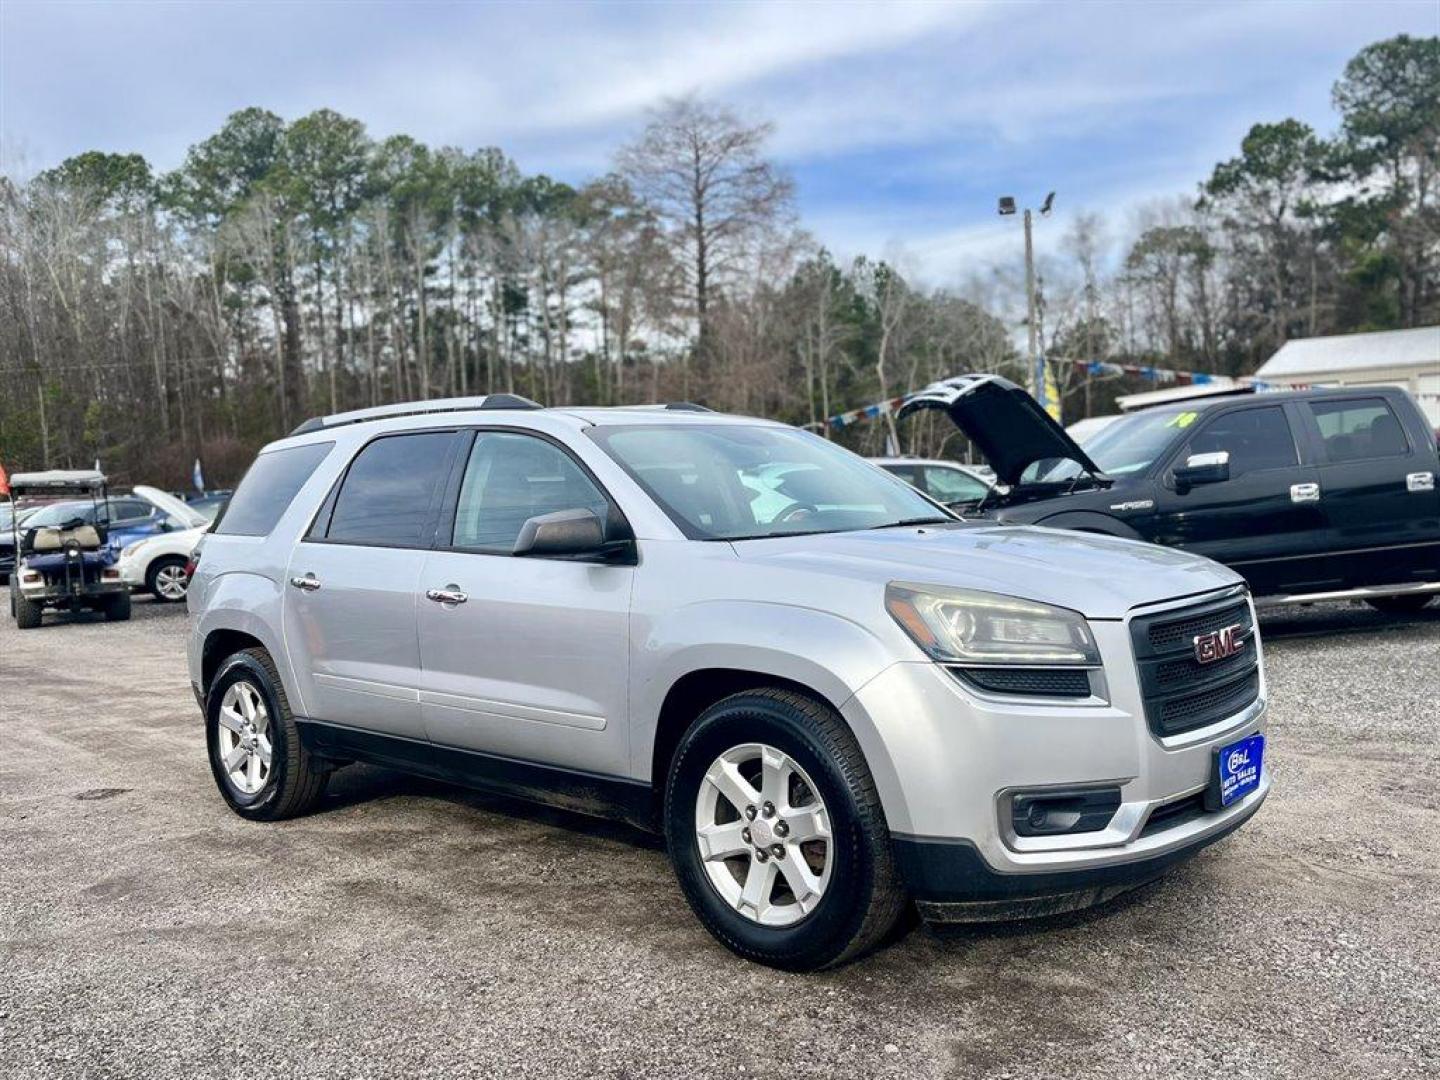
top-left (204, 648), bottom-right (330, 821)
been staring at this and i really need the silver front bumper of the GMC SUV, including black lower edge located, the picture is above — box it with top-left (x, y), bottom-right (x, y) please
top-left (841, 587), bottom-right (1272, 919)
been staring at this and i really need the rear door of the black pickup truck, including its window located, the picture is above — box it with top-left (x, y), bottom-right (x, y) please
top-left (1300, 392), bottom-right (1440, 588)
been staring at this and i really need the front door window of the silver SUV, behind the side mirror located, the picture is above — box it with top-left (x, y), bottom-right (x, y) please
top-left (452, 431), bottom-right (609, 554)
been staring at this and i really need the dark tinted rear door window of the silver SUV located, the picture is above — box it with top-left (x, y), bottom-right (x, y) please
top-left (325, 432), bottom-right (455, 547)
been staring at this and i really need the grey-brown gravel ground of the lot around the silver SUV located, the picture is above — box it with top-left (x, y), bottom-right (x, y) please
top-left (0, 602), bottom-right (1440, 1080)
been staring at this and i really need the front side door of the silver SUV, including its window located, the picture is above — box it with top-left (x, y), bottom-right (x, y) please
top-left (418, 431), bottom-right (635, 776)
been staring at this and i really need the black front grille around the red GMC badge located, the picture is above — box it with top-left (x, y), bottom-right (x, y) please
top-left (1130, 596), bottom-right (1260, 736)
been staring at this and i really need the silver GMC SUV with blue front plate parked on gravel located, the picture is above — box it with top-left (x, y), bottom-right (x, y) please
top-left (187, 396), bottom-right (1270, 971)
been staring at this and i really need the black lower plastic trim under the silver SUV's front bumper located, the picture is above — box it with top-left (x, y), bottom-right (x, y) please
top-left (891, 808), bottom-right (1254, 904)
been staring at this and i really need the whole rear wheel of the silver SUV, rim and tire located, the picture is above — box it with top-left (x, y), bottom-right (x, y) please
top-left (204, 648), bottom-right (330, 821)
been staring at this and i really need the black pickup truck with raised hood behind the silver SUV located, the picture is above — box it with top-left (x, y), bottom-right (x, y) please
top-left (900, 376), bottom-right (1440, 612)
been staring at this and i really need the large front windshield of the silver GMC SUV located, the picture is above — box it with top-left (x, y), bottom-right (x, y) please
top-left (588, 423), bottom-right (953, 540)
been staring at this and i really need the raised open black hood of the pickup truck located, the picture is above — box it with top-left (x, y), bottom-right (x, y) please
top-left (897, 374), bottom-right (1102, 487)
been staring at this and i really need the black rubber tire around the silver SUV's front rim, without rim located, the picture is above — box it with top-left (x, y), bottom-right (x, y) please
top-left (664, 688), bottom-right (906, 971)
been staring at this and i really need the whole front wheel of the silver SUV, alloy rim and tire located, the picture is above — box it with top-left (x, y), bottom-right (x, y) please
top-left (665, 688), bottom-right (906, 971)
